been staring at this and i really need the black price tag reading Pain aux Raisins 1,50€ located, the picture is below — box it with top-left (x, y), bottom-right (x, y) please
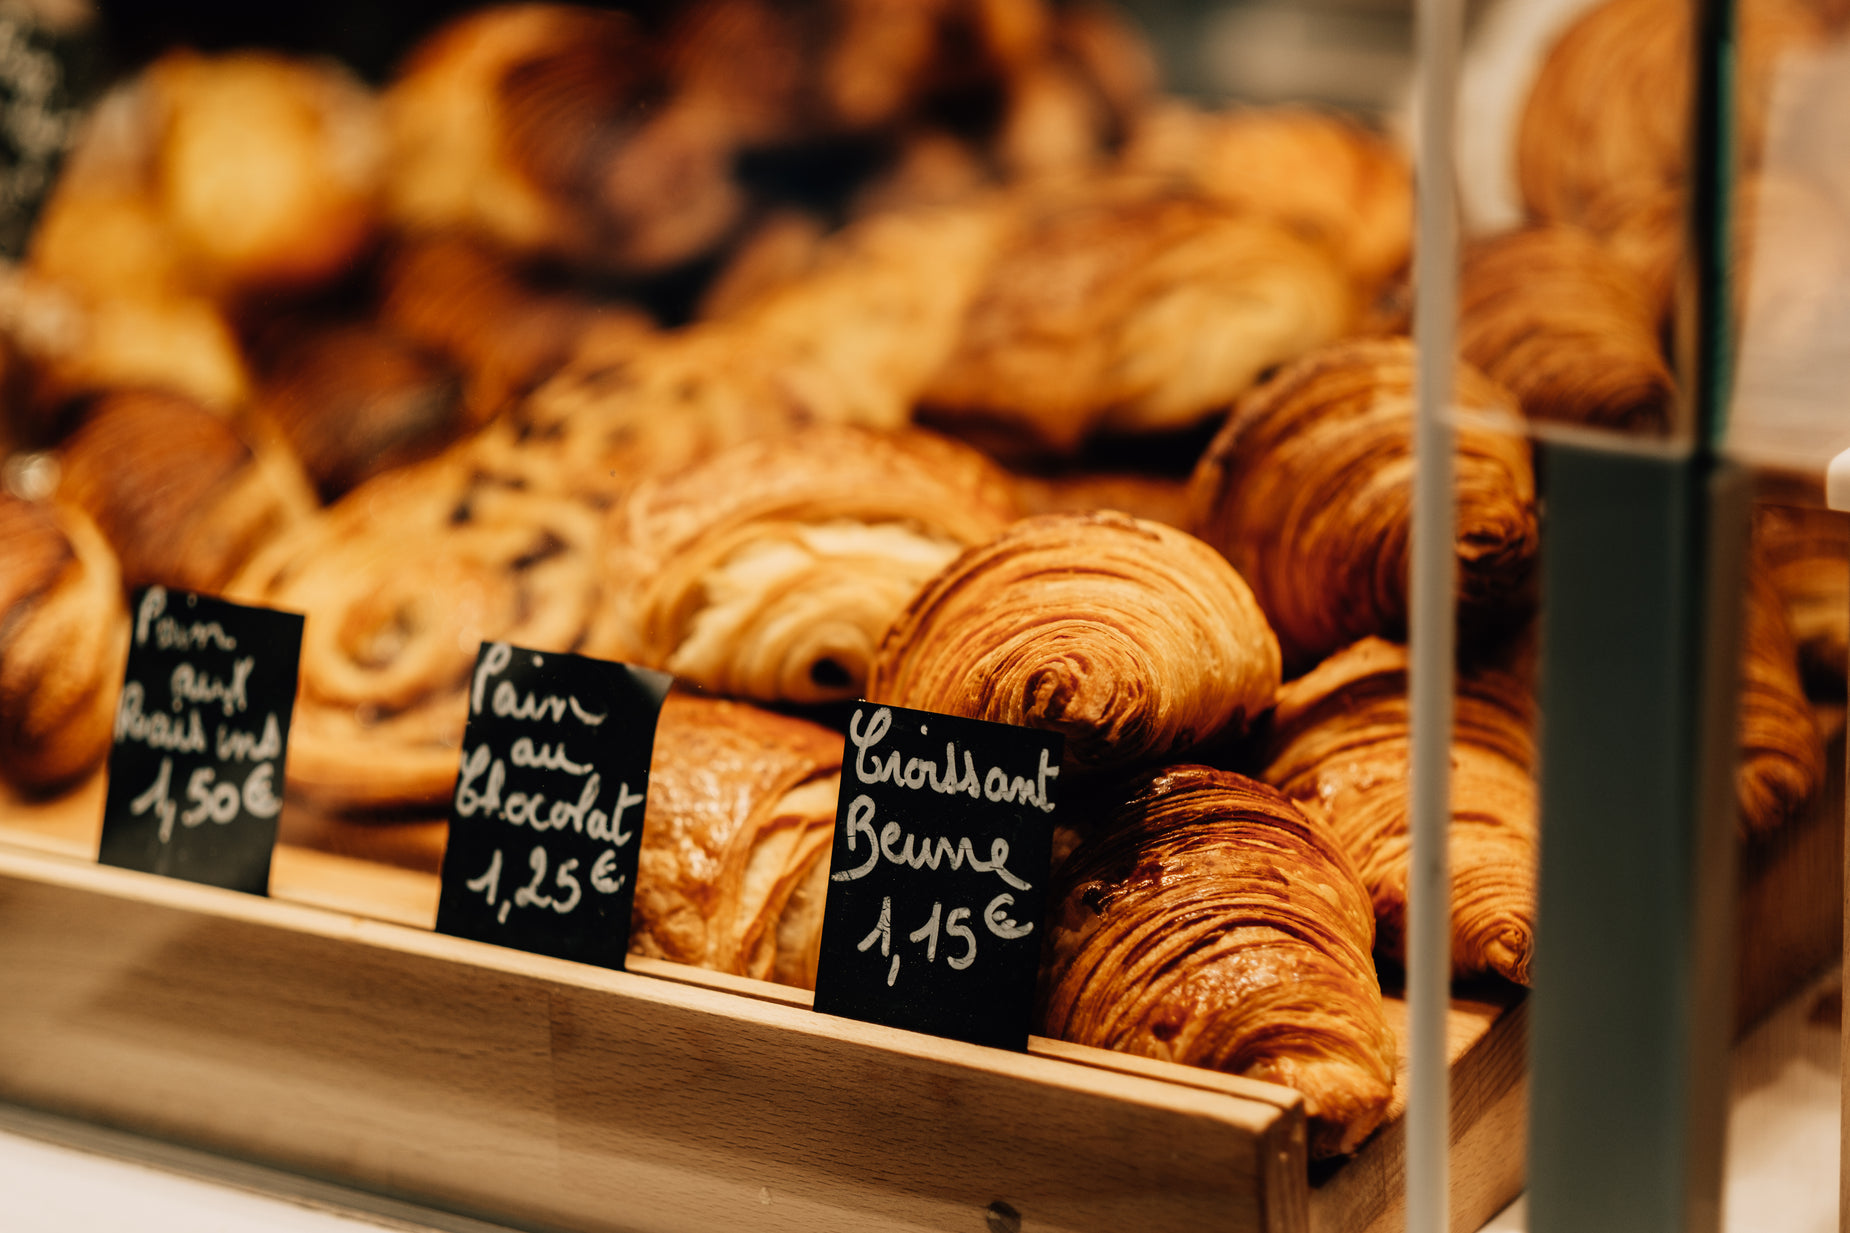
top-left (96, 587), bottom-right (302, 894)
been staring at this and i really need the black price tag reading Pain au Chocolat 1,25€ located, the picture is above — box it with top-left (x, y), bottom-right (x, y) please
top-left (437, 642), bottom-right (673, 968)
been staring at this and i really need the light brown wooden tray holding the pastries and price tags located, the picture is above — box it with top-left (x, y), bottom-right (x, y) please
top-left (0, 785), bottom-right (1526, 1233)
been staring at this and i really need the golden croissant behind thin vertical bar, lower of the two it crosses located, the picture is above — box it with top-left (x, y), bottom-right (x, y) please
top-left (1264, 639), bottom-right (1539, 985)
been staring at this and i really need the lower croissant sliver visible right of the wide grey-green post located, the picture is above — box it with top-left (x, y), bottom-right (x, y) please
top-left (1735, 565), bottom-right (1824, 837)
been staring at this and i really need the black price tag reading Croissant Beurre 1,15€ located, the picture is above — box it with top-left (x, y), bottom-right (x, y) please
top-left (816, 702), bottom-right (1064, 1050)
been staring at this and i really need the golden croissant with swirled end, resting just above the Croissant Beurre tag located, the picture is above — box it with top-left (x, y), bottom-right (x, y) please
top-left (868, 511), bottom-right (1278, 768)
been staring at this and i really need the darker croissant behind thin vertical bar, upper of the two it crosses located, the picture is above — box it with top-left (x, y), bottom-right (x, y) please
top-left (1191, 339), bottom-right (1537, 670)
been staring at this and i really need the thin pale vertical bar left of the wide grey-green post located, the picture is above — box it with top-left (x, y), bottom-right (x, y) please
top-left (1406, 0), bottom-right (1462, 1233)
